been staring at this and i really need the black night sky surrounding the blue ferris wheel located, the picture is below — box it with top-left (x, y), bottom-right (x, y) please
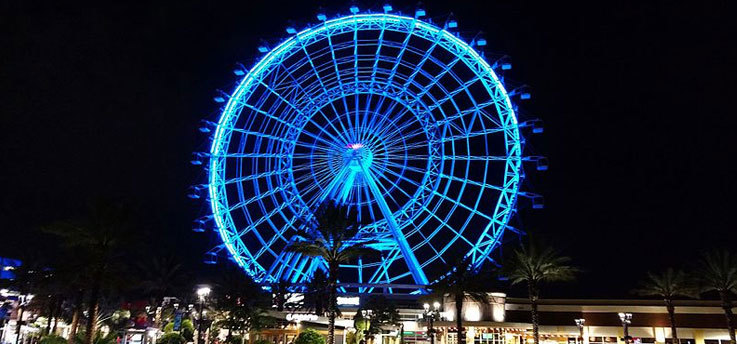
top-left (0, 0), bottom-right (737, 298)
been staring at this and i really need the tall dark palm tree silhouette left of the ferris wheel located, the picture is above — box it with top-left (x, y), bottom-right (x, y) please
top-left (46, 203), bottom-right (132, 344)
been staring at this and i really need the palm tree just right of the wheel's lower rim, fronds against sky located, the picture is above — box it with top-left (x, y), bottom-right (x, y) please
top-left (505, 242), bottom-right (578, 344)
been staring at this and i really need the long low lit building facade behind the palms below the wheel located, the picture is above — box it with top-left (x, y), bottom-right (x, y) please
top-left (272, 293), bottom-right (729, 344)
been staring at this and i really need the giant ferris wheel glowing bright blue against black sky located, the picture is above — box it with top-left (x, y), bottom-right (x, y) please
top-left (193, 8), bottom-right (546, 291)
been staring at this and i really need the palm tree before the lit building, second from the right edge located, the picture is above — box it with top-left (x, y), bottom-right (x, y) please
top-left (634, 268), bottom-right (695, 343)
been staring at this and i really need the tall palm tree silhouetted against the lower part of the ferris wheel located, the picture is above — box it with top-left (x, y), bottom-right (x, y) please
top-left (287, 203), bottom-right (377, 344)
